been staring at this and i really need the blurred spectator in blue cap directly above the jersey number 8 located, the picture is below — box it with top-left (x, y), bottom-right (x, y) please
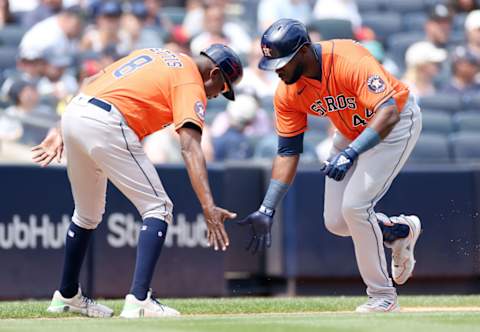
top-left (121, 1), bottom-right (163, 50)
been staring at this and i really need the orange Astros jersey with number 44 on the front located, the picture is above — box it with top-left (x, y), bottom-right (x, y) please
top-left (274, 39), bottom-right (409, 140)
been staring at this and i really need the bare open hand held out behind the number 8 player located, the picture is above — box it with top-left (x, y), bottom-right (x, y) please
top-left (32, 128), bottom-right (63, 167)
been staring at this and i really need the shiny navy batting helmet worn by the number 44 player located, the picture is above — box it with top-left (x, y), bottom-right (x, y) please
top-left (258, 18), bottom-right (311, 70)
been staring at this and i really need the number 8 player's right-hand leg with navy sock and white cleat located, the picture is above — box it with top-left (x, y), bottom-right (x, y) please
top-left (94, 110), bottom-right (178, 318)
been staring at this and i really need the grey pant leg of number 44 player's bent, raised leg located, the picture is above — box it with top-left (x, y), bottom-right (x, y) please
top-left (323, 132), bottom-right (355, 236)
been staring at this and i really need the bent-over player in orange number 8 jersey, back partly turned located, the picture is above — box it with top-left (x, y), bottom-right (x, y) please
top-left (33, 44), bottom-right (242, 318)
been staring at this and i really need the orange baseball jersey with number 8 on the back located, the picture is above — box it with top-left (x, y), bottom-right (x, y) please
top-left (82, 48), bottom-right (207, 140)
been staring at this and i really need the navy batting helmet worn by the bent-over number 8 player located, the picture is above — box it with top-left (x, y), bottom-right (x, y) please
top-left (200, 44), bottom-right (243, 100)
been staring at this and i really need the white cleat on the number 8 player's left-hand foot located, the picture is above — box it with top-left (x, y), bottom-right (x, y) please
top-left (47, 288), bottom-right (113, 317)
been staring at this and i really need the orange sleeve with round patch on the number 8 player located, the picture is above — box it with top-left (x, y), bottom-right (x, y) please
top-left (172, 83), bottom-right (207, 130)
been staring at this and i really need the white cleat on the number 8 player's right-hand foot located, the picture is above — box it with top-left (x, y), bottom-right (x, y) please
top-left (120, 290), bottom-right (180, 318)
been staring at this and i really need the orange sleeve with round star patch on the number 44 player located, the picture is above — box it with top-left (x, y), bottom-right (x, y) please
top-left (350, 56), bottom-right (395, 111)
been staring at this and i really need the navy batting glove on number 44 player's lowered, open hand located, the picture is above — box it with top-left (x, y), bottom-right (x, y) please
top-left (237, 205), bottom-right (275, 254)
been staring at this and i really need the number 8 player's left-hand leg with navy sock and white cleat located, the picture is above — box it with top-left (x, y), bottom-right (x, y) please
top-left (47, 105), bottom-right (113, 317)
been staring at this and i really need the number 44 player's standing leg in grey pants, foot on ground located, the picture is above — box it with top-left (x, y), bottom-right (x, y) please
top-left (342, 98), bottom-right (421, 311)
